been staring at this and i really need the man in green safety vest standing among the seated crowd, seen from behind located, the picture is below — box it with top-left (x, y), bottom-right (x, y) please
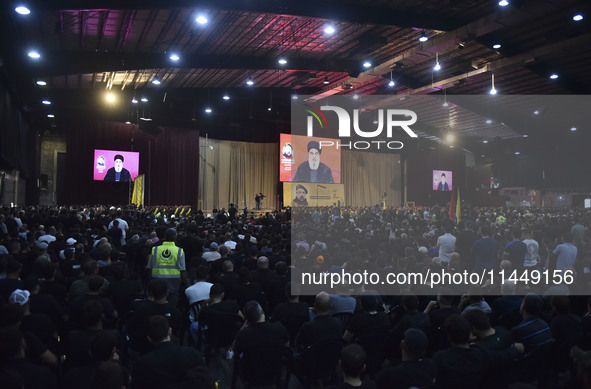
top-left (146, 228), bottom-right (188, 306)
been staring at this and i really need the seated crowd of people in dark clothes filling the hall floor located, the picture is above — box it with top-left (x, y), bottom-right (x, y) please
top-left (0, 204), bottom-right (591, 389)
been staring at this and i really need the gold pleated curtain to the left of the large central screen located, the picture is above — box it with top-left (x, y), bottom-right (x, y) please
top-left (199, 138), bottom-right (279, 210)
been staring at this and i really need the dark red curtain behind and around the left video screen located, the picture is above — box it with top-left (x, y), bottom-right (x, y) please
top-left (65, 121), bottom-right (199, 206)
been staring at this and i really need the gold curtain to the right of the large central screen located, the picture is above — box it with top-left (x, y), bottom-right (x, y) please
top-left (341, 150), bottom-right (402, 207)
